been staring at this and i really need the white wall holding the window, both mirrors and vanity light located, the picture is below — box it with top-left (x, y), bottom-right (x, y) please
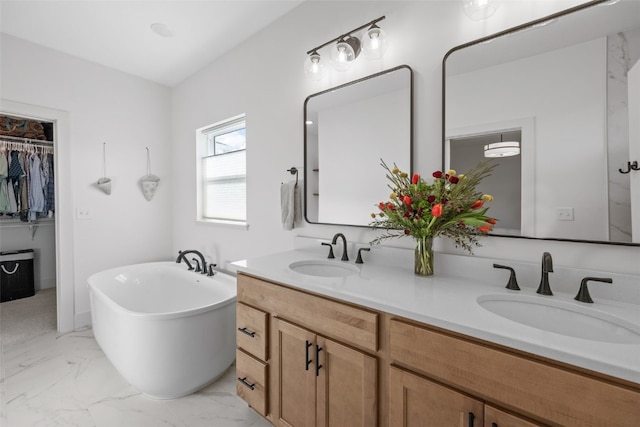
top-left (172, 1), bottom-right (640, 273)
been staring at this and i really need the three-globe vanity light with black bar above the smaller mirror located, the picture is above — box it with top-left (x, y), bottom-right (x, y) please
top-left (304, 16), bottom-right (388, 81)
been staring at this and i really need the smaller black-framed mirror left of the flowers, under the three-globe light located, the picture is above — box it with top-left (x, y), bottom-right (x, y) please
top-left (304, 65), bottom-right (413, 226)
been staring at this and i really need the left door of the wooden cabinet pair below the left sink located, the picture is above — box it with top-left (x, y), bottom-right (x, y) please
top-left (274, 320), bottom-right (316, 427)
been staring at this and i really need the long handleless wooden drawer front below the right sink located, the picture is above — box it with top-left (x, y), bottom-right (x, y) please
top-left (389, 319), bottom-right (640, 426)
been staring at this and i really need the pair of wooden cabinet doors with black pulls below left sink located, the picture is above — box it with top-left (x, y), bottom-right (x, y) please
top-left (274, 319), bottom-right (377, 427)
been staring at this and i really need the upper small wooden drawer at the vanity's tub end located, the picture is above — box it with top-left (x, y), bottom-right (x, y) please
top-left (236, 303), bottom-right (268, 361)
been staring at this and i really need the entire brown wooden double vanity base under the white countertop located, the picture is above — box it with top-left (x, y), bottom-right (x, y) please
top-left (236, 274), bottom-right (640, 427)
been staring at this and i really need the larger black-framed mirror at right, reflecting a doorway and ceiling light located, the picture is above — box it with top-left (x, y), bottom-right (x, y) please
top-left (443, 0), bottom-right (640, 245)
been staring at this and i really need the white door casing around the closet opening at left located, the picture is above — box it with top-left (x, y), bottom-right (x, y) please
top-left (0, 99), bottom-right (75, 333)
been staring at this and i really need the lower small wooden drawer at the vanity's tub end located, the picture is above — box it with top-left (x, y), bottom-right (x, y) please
top-left (236, 349), bottom-right (267, 416)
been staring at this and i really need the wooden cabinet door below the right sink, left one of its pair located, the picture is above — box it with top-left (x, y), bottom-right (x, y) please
top-left (389, 366), bottom-right (484, 427)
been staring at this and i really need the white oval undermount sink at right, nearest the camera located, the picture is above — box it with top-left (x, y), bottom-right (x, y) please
top-left (477, 295), bottom-right (640, 344)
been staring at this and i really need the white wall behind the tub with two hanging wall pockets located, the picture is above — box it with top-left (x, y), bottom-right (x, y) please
top-left (0, 34), bottom-right (173, 328)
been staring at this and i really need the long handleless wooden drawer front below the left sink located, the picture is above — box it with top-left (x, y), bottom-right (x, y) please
top-left (238, 274), bottom-right (379, 352)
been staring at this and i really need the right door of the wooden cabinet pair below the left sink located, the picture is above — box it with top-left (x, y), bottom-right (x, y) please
top-left (314, 337), bottom-right (378, 427)
